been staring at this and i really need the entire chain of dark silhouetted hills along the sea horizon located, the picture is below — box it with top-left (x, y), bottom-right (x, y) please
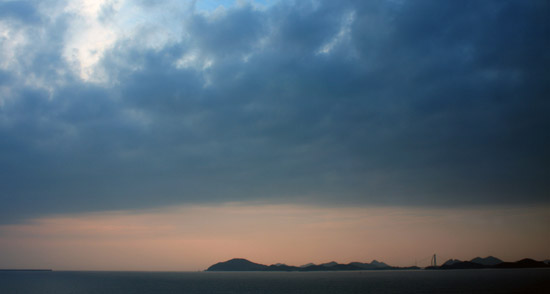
top-left (206, 256), bottom-right (550, 272)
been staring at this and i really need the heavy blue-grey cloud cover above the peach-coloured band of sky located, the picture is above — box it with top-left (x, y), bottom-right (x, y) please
top-left (0, 0), bottom-right (550, 222)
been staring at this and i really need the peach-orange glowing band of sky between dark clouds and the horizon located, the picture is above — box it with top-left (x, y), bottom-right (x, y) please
top-left (0, 203), bottom-right (550, 271)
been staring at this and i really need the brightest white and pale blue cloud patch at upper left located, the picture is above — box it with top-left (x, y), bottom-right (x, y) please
top-left (63, 0), bottom-right (196, 83)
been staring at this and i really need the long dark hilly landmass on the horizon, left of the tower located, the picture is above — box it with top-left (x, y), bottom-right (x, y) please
top-left (207, 258), bottom-right (420, 272)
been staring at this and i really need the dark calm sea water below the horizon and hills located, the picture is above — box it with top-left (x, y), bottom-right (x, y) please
top-left (0, 269), bottom-right (550, 294)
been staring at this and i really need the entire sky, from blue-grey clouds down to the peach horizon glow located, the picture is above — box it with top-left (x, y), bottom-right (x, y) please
top-left (0, 0), bottom-right (550, 270)
